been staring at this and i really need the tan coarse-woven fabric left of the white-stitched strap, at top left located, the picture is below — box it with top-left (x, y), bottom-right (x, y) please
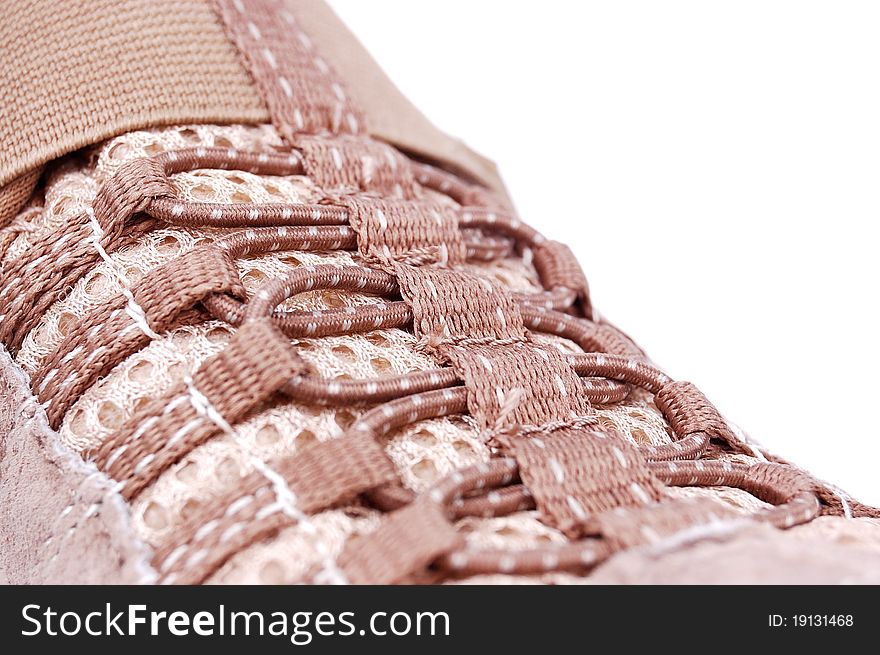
top-left (0, 0), bottom-right (268, 190)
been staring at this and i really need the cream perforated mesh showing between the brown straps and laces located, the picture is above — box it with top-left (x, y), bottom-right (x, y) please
top-left (4, 126), bottom-right (804, 583)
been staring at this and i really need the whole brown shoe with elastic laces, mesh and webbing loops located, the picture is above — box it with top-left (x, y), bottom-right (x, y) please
top-left (0, 0), bottom-right (880, 583)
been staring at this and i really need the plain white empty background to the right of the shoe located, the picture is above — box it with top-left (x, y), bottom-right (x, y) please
top-left (331, 0), bottom-right (880, 504)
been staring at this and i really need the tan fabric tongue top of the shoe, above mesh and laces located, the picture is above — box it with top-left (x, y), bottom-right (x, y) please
top-left (0, 0), bottom-right (503, 224)
